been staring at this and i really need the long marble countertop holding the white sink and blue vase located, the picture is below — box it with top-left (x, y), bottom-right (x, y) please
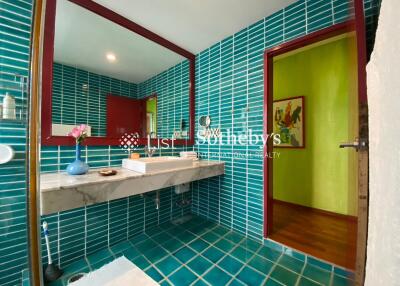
top-left (40, 160), bottom-right (224, 215)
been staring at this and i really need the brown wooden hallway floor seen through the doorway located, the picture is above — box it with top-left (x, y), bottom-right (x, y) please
top-left (270, 201), bottom-right (357, 269)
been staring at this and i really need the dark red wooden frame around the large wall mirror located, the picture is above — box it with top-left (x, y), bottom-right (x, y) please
top-left (41, 0), bottom-right (195, 146)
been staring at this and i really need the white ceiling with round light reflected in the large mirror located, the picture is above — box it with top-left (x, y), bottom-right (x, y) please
top-left (54, 0), bottom-right (185, 83)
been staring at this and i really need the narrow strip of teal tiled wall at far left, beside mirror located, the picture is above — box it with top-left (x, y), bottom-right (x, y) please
top-left (0, 0), bottom-right (32, 285)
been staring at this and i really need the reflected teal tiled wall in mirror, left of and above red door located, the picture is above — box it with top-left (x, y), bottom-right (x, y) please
top-left (52, 63), bottom-right (137, 136)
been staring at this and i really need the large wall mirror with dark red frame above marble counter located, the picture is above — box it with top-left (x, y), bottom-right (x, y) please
top-left (42, 0), bottom-right (195, 145)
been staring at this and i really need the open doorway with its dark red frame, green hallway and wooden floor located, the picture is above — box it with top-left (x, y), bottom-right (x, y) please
top-left (264, 21), bottom-right (368, 276)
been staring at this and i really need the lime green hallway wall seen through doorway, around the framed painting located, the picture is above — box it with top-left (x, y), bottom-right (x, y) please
top-left (273, 35), bottom-right (357, 215)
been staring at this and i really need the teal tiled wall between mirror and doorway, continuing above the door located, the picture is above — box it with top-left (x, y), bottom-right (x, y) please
top-left (192, 0), bottom-right (380, 242)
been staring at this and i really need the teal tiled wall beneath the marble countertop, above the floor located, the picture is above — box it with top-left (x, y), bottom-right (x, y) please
top-left (41, 187), bottom-right (191, 267)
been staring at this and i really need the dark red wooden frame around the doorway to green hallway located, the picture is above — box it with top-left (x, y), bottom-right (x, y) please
top-left (263, 0), bottom-right (368, 280)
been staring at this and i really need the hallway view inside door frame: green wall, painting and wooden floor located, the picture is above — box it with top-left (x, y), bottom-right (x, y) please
top-left (270, 33), bottom-right (358, 269)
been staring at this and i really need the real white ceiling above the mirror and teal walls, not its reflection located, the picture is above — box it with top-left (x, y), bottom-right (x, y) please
top-left (94, 0), bottom-right (296, 54)
